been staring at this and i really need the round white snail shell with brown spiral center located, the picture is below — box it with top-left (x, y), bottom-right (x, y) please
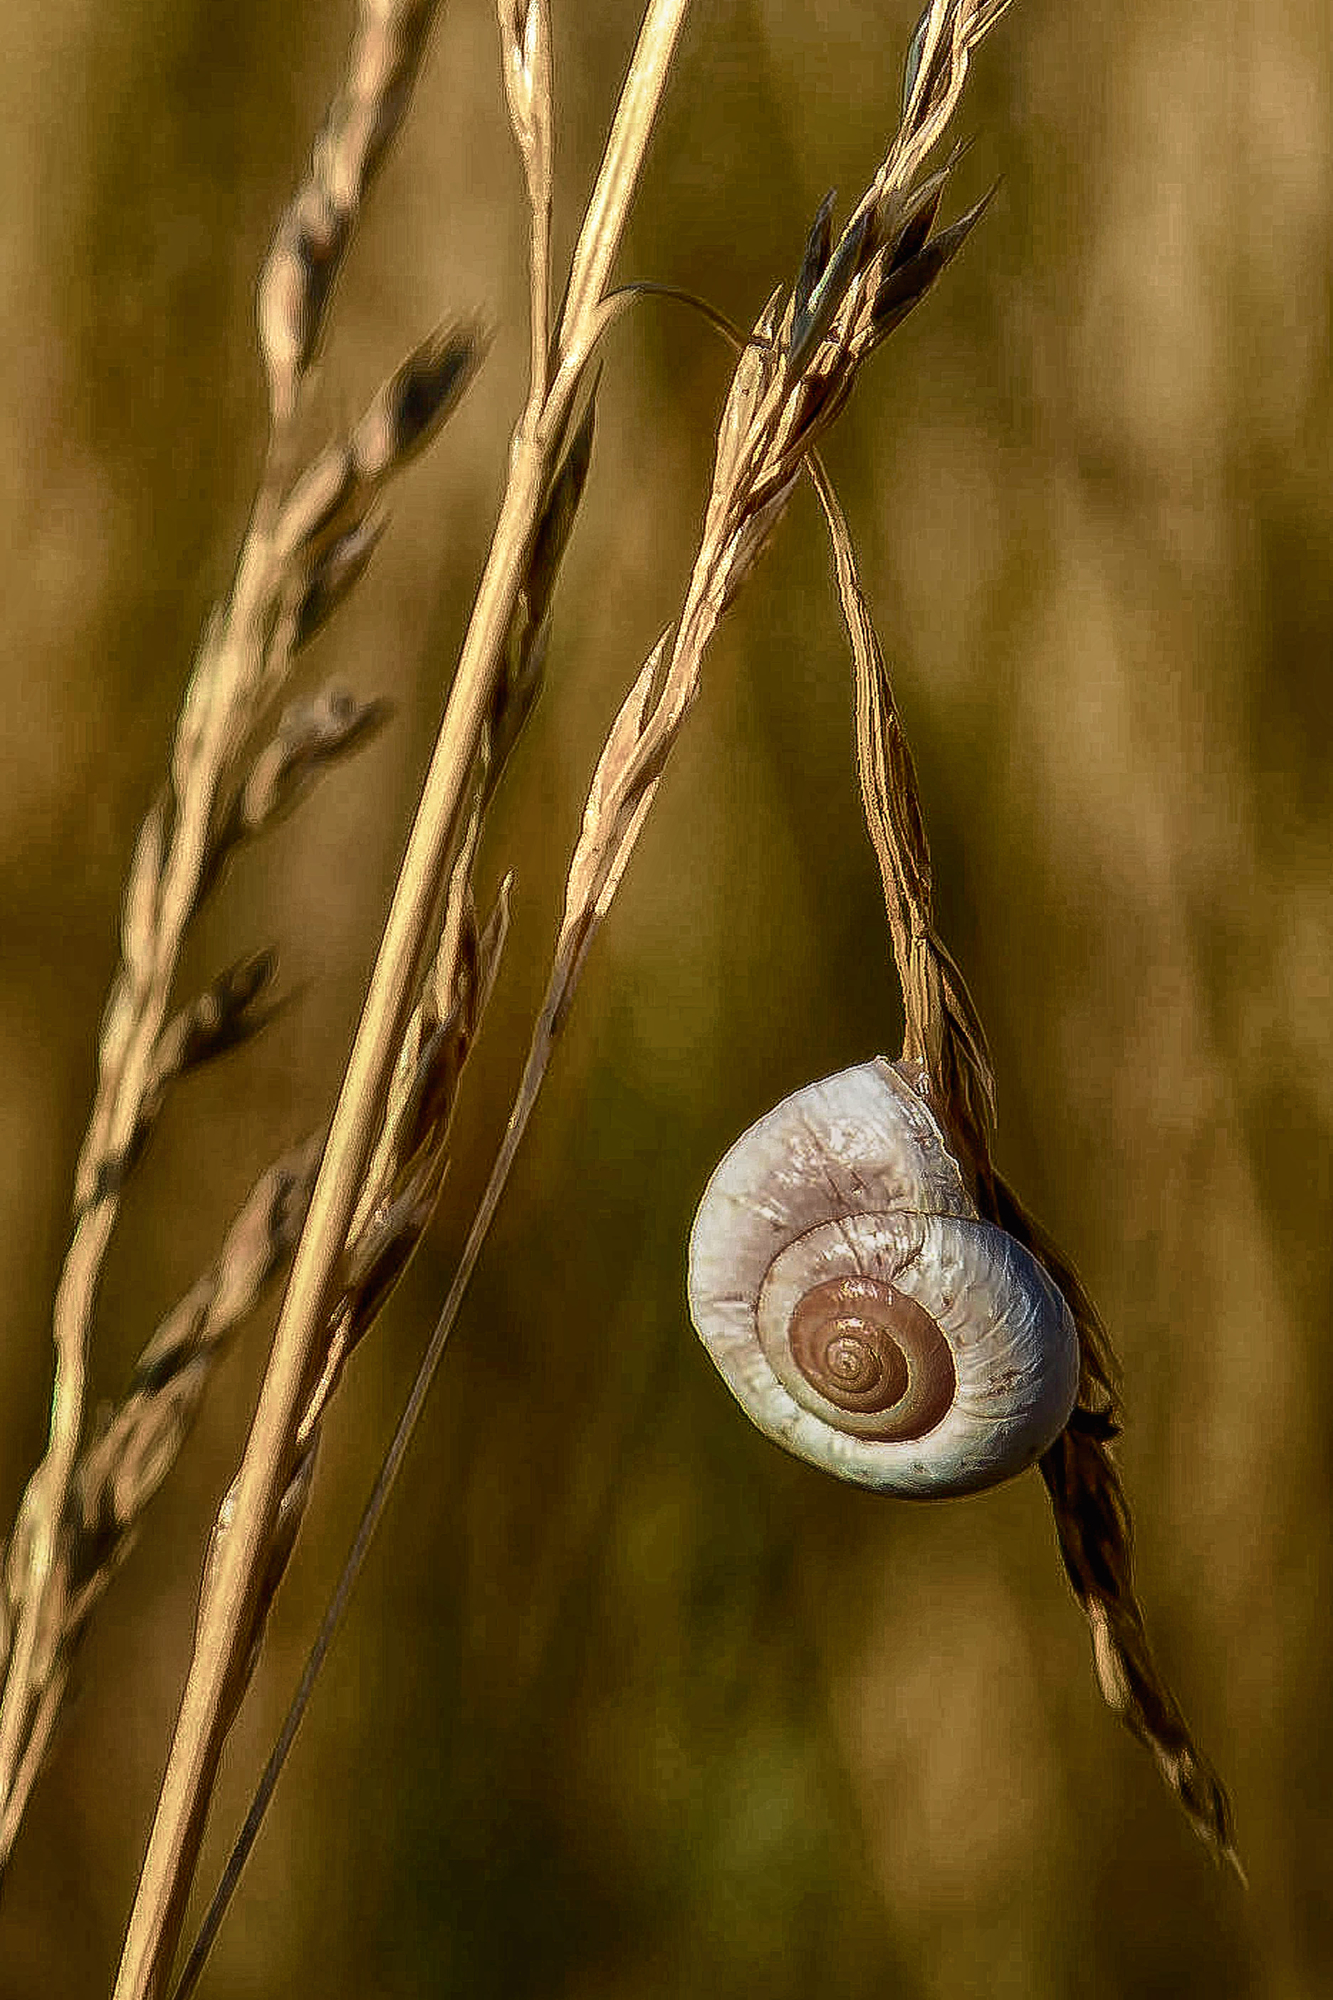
top-left (689, 1058), bottom-right (1079, 1498)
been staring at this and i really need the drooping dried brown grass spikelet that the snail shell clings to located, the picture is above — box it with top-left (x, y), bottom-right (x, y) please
top-left (811, 450), bottom-right (1243, 1878)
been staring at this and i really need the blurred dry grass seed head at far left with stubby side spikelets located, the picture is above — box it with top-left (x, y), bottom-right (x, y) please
top-left (0, 0), bottom-right (482, 1866)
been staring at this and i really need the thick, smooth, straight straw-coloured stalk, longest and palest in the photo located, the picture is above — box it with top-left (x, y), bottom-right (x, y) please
top-left (114, 0), bottom-right (689, 2000)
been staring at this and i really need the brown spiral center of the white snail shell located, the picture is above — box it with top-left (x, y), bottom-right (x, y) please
top-left (789, 1276), bottom-right (957, 1440)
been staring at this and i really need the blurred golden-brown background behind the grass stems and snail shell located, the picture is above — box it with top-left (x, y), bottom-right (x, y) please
top-left (0, 0), bottom-right (1333, 2000)
